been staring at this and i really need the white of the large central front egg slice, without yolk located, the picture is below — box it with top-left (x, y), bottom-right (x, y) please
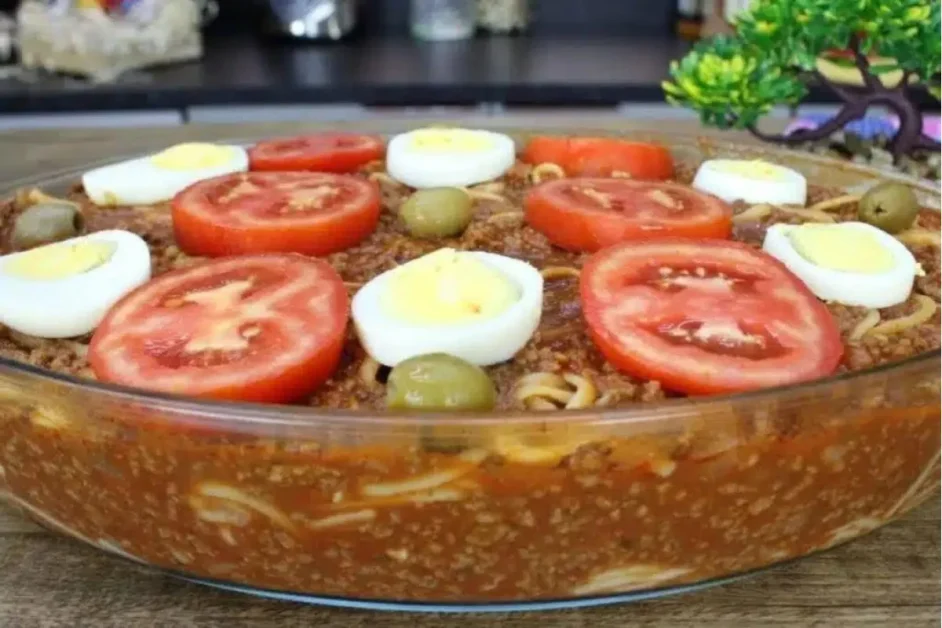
top-left (351, 251), bottom-right (543, 366)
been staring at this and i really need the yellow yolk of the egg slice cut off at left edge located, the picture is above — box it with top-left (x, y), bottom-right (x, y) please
top-left (3, 242), bottom-right (117, 281)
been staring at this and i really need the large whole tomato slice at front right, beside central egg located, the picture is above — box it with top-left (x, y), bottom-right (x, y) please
top-left (580, 239), bottom-right (843, 394)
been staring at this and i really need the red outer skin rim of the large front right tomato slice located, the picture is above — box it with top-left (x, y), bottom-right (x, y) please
top-left (580, 238), bottom-right (844, 395)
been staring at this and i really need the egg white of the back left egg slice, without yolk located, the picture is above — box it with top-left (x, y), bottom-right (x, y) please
top-left (82, 146), bottom-right (249, 206)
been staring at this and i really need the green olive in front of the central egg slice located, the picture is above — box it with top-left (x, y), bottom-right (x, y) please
top-left (386, 353), bottom-right (497, 410)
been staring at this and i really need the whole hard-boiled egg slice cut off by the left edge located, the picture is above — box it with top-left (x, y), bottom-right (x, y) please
top-left (0, 230), bottom-right (151, 338)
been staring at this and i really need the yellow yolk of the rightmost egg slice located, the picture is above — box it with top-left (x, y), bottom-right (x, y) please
top-left (788, 224), bottom-right (894, 273)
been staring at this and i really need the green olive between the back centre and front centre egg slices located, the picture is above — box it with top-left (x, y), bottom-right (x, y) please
top-left (399, 188), bottom-right (474, 238)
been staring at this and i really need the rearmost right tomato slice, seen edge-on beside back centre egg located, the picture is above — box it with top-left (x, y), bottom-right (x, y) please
top-left (523, 135), bottom-right (674, 181)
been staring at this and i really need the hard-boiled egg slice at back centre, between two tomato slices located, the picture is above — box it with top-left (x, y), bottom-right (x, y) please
top-left (386, 128), bottom-right (516, 188)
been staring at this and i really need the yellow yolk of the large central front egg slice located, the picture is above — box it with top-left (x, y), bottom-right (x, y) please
top-left (380, 249), bottom-right (520, 325)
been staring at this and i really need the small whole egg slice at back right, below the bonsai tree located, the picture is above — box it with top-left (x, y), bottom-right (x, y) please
top-left (693, 159), bottom-right (808, 205)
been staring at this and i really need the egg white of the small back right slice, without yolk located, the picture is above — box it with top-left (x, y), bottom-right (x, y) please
top-left (691, 159), bottom-right (808, 206)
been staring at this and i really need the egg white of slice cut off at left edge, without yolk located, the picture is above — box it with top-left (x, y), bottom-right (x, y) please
top-left (0, 230), bottom-right (151, 338)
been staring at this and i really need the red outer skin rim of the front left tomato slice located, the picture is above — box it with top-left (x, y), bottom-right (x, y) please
top-left (88, 255), bottom-right (350, 403)
